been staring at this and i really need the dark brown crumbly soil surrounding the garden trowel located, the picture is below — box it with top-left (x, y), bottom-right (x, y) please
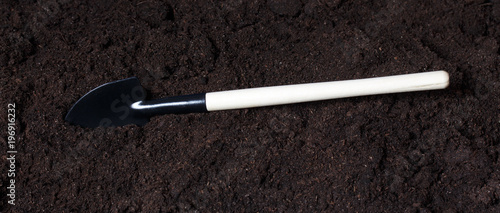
top-left (0, 0), bottom-right (500, 212)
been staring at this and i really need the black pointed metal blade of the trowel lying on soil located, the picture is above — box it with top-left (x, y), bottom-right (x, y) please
top-left (65, 77), bottom-right (149, 127)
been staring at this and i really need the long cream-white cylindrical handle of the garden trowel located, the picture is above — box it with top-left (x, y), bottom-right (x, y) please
top-left (206, 71), bottom-right (449, 111)
